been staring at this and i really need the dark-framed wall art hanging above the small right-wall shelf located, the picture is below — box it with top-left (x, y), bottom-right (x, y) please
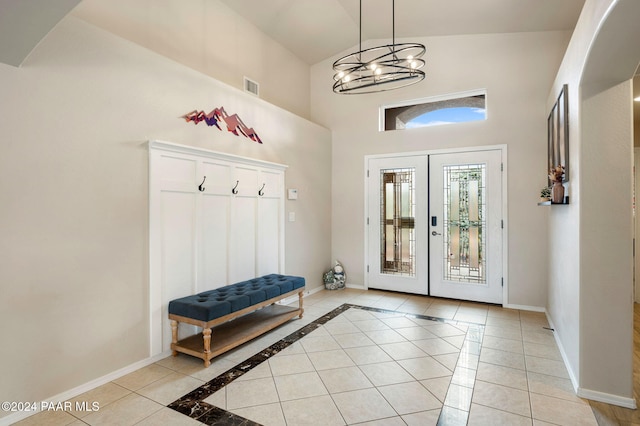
top-left (547, 84), bottom-right (569, 185)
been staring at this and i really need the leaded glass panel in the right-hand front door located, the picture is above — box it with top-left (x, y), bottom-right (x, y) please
top-left (443, 164), bottom-right (486, 284)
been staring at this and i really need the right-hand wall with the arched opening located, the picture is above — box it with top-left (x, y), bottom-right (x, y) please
top-left (547, 0), bottom-right (640, 407)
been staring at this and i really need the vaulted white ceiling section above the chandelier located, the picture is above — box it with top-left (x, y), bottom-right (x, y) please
top-left (221, 0), bottom-right (584, 64)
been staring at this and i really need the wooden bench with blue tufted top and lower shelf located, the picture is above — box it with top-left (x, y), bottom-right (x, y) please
top-left (169, 274), bottom-right (305, 367)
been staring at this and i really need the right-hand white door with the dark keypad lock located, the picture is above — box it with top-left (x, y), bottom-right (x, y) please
top-left (429, 150), bottom-right (502, 303)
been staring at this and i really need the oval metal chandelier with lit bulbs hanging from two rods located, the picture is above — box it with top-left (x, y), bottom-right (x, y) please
top-left (333, 0), bottom-right (426, 94)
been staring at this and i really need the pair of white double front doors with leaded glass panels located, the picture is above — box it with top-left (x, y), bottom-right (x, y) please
top-left (367, 149), bottom-right (503, 303)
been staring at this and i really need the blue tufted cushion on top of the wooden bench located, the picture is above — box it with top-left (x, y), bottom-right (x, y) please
top-left (169, 274), bottom-right (305, 321)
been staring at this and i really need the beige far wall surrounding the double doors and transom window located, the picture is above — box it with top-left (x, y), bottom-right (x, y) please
top-left (311, 32), bottom-right (570, 307)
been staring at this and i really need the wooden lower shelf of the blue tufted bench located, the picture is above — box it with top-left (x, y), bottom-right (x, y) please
top-left (171, 305), bottom-right (303, 367)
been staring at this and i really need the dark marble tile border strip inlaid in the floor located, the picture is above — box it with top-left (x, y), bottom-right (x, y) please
top-left (167, 303), bottom-right (483, 426)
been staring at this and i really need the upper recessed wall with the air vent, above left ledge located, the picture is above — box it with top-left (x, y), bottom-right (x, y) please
top-left (72, 0), bottom-right (309, 118)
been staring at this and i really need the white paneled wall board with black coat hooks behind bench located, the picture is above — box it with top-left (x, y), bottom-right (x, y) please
top-left (149, 141), bottom-right (286, 356)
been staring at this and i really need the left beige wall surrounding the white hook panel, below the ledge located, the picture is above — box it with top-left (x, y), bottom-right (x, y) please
top-left (0, 17), bottom-right (331, 416)
